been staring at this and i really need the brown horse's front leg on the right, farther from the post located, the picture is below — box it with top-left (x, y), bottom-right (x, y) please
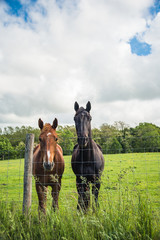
top-left (52, 178), bottom-right (61, 211)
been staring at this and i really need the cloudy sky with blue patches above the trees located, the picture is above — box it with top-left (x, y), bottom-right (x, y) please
top-left (0, 0), bottom-right (160, 128)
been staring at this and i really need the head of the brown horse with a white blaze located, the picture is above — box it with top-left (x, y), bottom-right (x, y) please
top-left (38, 118), bottom-right (58, 171)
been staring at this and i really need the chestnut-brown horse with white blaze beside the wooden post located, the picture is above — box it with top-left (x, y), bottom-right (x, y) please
top-left (33, 118), bottom-right (64, 213)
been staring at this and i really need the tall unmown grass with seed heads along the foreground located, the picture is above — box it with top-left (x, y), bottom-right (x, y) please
top-left (0, 193), bottom-right (160, 240)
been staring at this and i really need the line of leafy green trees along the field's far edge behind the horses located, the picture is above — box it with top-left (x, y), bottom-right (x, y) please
top-left (0, 121), bottom-right (160, 160)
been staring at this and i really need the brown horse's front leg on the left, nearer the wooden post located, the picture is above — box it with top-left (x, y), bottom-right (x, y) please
top-left (36, 183), bottom-right (48, 213)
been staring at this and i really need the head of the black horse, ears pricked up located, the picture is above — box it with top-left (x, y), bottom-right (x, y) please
top-left (74, 102), bottom-right (92, 148)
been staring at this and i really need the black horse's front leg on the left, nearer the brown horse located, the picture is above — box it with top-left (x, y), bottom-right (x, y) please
top-left (76, 177), bottom-right (90, 210)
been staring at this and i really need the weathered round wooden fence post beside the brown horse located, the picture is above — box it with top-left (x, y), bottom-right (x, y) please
top-left (23, 134), bottom-right (34, 214)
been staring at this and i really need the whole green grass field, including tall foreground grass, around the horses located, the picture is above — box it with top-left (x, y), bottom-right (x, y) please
top-left (0, 153), bottom-right (160, 240)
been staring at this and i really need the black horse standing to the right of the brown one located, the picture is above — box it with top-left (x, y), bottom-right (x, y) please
top-left (71, 102), bottom-right (104, 210)
